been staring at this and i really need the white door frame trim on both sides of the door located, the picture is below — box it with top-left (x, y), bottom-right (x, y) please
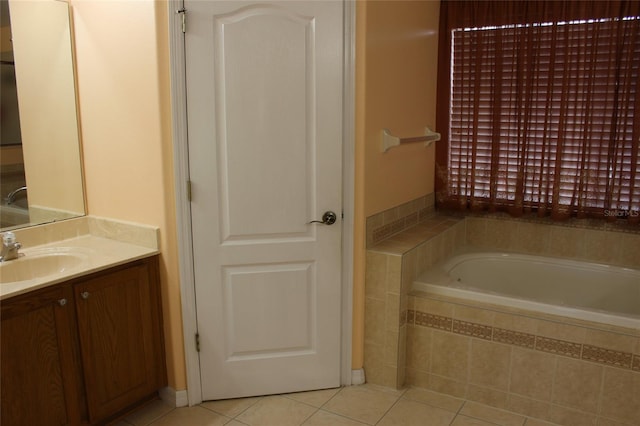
top-left (167, 0), bottom-right (356, 405)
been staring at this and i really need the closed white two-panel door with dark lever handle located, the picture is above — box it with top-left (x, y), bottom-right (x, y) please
top-left (185, 0), bottom-right (343, 400)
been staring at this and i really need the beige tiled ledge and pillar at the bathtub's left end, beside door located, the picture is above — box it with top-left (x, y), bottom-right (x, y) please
top-left (364, 215), bottom-right (465, 388)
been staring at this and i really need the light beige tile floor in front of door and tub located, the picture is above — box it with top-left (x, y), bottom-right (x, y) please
top-left (114, 385), bottom-right (552, 426)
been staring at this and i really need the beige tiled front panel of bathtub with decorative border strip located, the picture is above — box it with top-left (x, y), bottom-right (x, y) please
top-left (406, 293), bottom-right (640, 426)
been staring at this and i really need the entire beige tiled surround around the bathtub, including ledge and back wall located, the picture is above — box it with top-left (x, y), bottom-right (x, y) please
top-left (365, 206), bottom-right (640, 425)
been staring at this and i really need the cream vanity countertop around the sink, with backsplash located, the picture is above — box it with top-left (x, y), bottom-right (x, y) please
top-left (0, 220), bottom-right (159, 300)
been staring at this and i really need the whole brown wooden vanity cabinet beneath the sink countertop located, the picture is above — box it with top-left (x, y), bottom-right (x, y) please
top-left (0, 256), bottom-right (166, 426)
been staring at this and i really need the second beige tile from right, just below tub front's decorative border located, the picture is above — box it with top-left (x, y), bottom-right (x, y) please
top-left (552, 357), bottom-right (604, 413)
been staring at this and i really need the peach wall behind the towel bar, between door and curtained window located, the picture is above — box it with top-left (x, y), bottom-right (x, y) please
top-left (352, 0), bottom-right (440, 369)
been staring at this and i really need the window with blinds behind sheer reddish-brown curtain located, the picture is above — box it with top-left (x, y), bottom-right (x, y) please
top-left (437, 2), bottom-right (640, 222)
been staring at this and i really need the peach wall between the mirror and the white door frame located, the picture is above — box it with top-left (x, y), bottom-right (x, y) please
top-left (71, 0), bottom-right (186, 390)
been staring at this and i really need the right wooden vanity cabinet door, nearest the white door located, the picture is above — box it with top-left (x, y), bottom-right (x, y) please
top-left (74, 262), bottom-right (164, 423)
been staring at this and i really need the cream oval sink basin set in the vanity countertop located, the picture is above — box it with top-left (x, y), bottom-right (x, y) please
top-left (0, 248), bottom-right (88, 284)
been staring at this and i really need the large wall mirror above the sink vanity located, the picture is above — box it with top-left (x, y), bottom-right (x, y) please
top-left (0, 0), bottom-right (85, 231)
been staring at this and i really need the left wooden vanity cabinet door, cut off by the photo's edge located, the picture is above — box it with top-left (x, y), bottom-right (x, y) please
top-left (0, 287), bottom-right (80, 426)
